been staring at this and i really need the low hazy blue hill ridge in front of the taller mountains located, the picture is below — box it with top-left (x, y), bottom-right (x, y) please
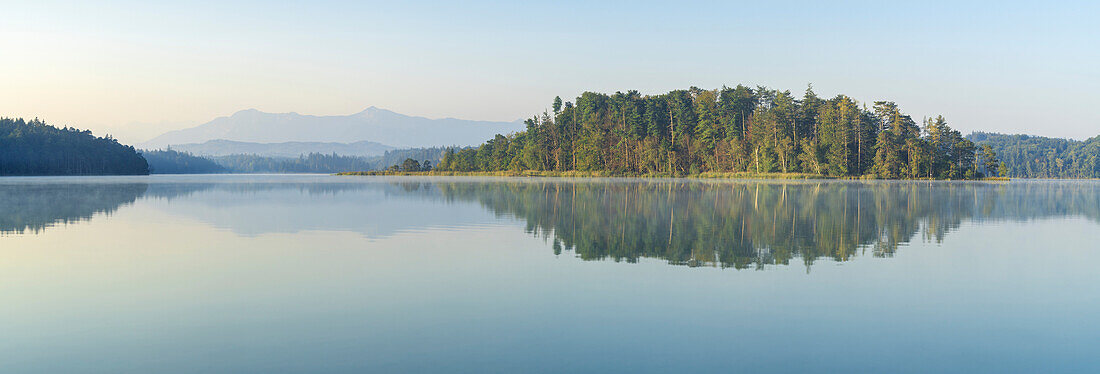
top-left (155, 139), bottom-right (395, 157)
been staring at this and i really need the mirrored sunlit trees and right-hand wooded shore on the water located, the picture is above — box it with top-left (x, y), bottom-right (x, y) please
top-left (429, 182), bottom-right (1100, 268)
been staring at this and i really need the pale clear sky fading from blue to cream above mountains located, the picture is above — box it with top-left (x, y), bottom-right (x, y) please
top-left (0, 0), bottom-right (1100, 142)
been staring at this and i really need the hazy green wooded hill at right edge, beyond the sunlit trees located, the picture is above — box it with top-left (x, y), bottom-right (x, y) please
top-left (967, 132), bottom-right (1100, 178)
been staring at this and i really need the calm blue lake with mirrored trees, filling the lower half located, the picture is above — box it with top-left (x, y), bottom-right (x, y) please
top-left (0, 175), bottom-right (1100, 373)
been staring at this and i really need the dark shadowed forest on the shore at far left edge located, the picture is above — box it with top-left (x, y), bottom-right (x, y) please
top-left (0, 118), bottom-right (149, 175)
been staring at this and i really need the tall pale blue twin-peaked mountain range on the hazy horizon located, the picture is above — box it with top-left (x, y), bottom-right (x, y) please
top-left (136, 107), bottom-right (524, 149)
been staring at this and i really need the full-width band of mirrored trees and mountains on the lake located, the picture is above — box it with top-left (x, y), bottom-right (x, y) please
top-left (0, 177), bottom-right (1100, 268)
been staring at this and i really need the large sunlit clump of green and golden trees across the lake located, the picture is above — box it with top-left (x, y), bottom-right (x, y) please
top-left (437, 85), bottom-right (1000, 179)
